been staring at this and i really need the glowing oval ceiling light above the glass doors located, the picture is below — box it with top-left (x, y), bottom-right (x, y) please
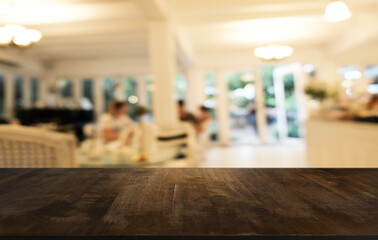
top-left (254, 45), bottom-right (293, 60)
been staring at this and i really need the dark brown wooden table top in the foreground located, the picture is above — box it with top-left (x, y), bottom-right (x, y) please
top-left (0, 169), bottom-right (378, 239)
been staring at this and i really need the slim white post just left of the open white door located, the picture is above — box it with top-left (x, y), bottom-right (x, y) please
top-left (254, 69), bottom-right (268, 144)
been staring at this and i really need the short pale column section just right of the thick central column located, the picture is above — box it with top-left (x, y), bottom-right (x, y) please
top-left (185, 68), bottom-right (205, 113)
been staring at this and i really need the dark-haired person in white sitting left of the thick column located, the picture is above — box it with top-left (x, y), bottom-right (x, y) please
top-left (98, 101), bottom-right (134, 142)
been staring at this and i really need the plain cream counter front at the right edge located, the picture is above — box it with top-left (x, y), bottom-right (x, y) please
top-left (306, 119), bottom-right (378, 168)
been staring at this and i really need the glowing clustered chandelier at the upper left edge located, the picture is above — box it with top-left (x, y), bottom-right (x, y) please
top-left (0, 24), bottom-right (42, 47)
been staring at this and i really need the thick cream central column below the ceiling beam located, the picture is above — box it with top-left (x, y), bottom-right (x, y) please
top-left (148, 21), bottom-right (178, 125)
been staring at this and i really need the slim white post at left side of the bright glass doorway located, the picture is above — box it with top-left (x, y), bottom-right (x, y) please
top-left (215, 71), bottom-right (230, 146)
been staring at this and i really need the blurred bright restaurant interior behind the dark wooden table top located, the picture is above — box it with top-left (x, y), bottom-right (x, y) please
top-left (0, 0), bottom-right (378, 168)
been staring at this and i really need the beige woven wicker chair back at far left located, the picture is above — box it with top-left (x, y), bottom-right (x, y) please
top-left (0, 125), bottom-right (76, 168)
